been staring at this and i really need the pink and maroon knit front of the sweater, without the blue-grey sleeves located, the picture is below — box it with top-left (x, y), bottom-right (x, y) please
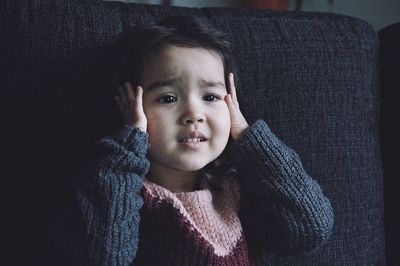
top-left (134, 178), bottom-right (264, 266)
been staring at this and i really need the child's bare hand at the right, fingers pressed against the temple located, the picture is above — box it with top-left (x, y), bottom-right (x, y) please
top-left (224, 73), bottom-right (249, 141)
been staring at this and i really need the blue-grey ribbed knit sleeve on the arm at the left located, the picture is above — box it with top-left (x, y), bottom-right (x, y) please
top-left (48, 126), bottom-right (149, 266)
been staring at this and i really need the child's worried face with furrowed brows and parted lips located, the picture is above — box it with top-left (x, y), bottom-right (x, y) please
top-left (141, 46), bottom-right (230, 172)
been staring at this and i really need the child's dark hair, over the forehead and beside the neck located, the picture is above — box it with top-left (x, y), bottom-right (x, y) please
top-left (115, 15), bottom-right (236, 189)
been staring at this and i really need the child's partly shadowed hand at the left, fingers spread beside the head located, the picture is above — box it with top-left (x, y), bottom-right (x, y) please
top-left (114, 82), bottom-right (147, 132)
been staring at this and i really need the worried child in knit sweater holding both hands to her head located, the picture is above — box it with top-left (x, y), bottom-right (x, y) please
top-left (52, 16), bottom-right (333, 266)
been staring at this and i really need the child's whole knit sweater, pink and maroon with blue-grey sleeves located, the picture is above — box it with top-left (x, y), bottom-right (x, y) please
top-left (50, 120), bottom-right (334, 266)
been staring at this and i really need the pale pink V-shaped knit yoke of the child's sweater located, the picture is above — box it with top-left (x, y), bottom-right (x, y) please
top-left (142, 179), bottom-right (242, 256)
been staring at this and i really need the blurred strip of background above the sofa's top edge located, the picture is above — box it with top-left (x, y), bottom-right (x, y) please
top-left (106, 0), bottom-right (400, 31)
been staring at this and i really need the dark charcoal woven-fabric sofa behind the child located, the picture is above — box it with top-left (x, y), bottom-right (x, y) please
top-left (0, 0), bottom-right (387, 265)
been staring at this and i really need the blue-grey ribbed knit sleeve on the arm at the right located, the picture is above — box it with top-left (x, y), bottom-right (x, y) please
top-left (229, 120), bottom-right (334, 255)
